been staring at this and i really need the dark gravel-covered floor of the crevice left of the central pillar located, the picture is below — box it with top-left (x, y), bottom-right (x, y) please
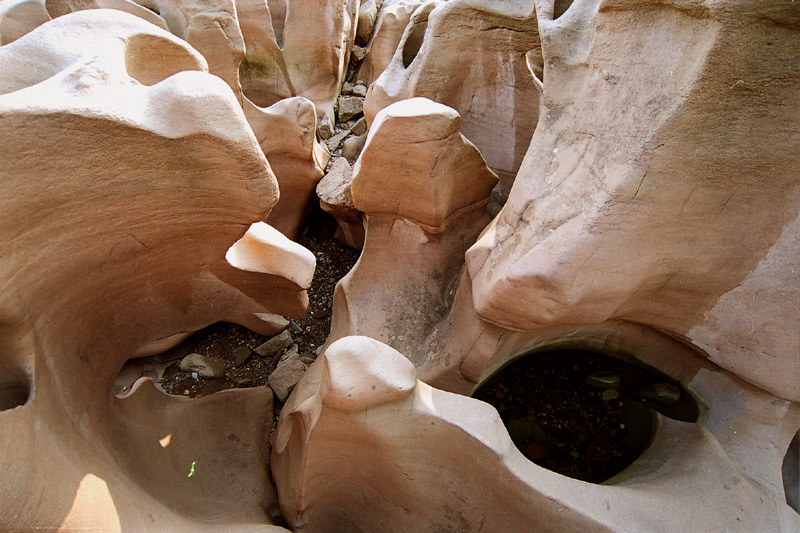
top-left (114, 206), bottom-right (360, 400)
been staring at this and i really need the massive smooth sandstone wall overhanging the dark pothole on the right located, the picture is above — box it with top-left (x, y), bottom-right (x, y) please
top-left (467, 2), bottom-right (800, 401)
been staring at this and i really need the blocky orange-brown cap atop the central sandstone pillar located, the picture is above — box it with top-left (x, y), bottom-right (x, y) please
top-left (352, 98), bottom-right (497, 231)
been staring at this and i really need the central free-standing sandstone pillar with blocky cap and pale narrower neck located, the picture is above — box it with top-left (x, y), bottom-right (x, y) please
top-left (328, 98), bottom-right (497, 358)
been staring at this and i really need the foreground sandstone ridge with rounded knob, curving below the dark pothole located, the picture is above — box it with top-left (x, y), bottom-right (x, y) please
top-left (272, 337), bottom-right (798, 531)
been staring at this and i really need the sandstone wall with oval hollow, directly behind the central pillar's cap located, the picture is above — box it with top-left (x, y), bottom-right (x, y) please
top-left (364, 0), bottom-right (542, 198)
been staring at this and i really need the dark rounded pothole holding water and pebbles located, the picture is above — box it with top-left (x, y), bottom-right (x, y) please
top-left (473, 350), bottom-right (698, 483)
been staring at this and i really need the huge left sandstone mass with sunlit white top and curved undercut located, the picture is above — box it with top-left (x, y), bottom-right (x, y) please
top-left (0, 10), bottom-right (307, 531)
